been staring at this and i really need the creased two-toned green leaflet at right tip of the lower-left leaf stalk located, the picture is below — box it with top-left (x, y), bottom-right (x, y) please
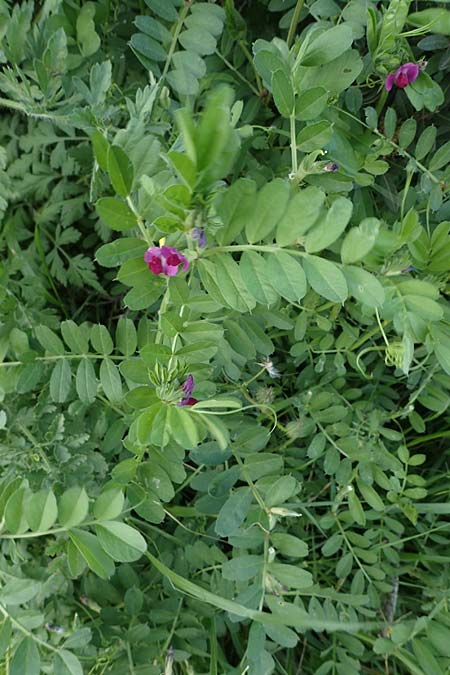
top-left (95, 520), bottom-right (147, 562)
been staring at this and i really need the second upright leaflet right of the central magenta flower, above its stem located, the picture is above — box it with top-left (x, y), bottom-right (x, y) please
top-left (245, 178), bottom-right (290, 244)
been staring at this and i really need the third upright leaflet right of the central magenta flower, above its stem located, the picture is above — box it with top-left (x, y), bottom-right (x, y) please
top-left (276, 185), bottom-right (325, 246)
